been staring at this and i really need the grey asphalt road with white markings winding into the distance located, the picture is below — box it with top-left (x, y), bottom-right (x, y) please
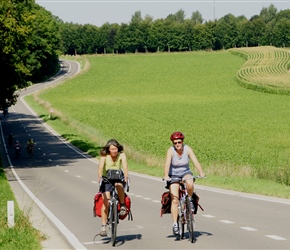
top-left (1, 59), bottom-right (290, 249)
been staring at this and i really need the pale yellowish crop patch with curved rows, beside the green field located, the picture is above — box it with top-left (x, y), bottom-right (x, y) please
top-left (230, 46), bottom-right (290, 94)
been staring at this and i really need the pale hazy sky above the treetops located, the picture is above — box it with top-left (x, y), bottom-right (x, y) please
top-left (35, 0), bottom-right (290, 27)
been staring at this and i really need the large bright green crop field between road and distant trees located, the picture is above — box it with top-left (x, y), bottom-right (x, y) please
top-left (30, 47), bottom-right (290, 185)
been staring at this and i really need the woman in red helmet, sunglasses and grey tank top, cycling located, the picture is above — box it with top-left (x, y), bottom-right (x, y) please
top-left (164, 132), bottom-right (205, 235)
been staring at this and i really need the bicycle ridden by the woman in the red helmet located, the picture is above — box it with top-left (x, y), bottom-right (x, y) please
top-left (164, 176), bottom-right (204, 243)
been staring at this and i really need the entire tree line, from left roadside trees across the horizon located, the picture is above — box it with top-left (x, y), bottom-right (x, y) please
top-left (0, 0), bottom-right (290, 110)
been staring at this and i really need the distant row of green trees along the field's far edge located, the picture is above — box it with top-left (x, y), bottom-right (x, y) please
top-left (60, 5), bottom-right (290, 55)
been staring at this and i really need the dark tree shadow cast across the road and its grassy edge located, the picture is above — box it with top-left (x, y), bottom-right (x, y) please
top-left (1, 110), bottom-right (100, 168)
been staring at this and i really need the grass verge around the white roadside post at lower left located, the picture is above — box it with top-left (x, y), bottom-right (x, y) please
top-left (0, 157), bottom-right (45, 250)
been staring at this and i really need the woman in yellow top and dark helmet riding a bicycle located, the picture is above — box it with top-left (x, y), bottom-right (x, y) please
top-left (98, 139), bottom-right (128, 237)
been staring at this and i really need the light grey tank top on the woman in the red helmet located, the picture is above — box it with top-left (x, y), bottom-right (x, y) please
top-left (169, 145), bottom-right (190, 177)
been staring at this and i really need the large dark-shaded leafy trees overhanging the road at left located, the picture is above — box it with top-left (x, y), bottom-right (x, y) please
top-left (0, 0), bottom-right (62, 110)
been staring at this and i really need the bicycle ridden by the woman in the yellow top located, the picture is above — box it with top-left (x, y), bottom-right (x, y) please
top-left (100, 176), bottom-right (129, 246)
